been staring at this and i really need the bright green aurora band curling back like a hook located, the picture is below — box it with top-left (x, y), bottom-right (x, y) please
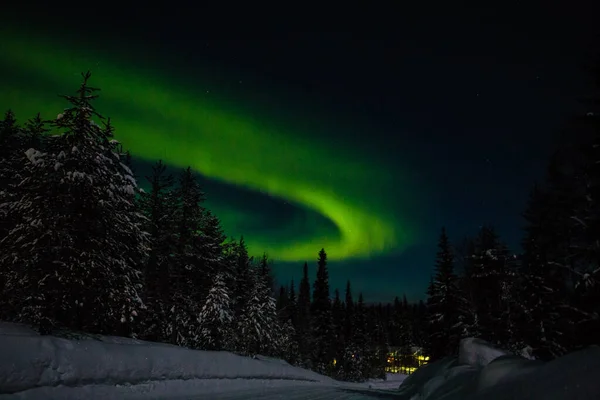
top-left (0, 36), bottom-right (414, 261)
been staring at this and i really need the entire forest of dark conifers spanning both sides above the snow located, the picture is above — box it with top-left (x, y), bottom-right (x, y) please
top-left (0, 72), bottom-right (600, 381)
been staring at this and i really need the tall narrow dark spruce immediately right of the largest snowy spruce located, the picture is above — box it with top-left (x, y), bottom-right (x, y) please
top-left (138, 160), bottom-right (175, 342)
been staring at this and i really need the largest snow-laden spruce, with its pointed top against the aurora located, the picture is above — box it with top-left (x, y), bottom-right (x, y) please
top-left (0, 72), bottom-right (148, 334)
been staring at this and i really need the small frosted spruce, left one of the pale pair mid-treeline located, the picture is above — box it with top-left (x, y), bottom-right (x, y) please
top-left (199, 274), bottom-right (233, 350)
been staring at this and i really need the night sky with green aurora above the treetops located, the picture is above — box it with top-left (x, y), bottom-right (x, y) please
top-left (0, 2), bottom-right (593, 301)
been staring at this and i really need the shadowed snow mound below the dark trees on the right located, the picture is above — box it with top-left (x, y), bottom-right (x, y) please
top-left (399, 338), bottom-right (600, 400)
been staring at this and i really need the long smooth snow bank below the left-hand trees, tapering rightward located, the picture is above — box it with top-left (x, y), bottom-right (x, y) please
top-left (0, 328), bottom-right (332, 394)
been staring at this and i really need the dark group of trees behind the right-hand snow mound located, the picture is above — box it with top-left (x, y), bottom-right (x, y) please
top-left (426, 62), bottom-right (600, 360)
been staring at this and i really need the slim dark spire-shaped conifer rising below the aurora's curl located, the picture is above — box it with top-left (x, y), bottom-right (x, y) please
top-left (310, 249), bottom-right (333, 372)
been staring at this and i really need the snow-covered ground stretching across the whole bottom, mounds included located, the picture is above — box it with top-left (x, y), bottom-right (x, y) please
top-left (0, 323), bottom-right (600, 400)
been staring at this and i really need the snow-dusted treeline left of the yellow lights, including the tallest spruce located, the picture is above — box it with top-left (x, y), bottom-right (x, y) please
top-left (0, 73), bottom-right (425, 381)
